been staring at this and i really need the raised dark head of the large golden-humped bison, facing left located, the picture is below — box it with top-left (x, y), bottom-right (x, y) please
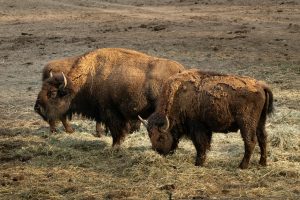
top-left (34, 72), bottom-right (74, 121)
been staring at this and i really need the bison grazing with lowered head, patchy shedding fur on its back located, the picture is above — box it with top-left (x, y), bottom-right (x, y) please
top-left (140, 69), bottom-right (273, 169)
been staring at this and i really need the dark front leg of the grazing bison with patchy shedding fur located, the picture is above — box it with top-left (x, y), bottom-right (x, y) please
top-left (190, 123), bottom-right (212, 166)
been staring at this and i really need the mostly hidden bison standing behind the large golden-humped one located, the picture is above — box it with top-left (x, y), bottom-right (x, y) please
top-left (34, 56), bottom-right (108, 137)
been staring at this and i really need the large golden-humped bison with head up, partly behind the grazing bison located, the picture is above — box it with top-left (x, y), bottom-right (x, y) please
top-left (36, 48), bottom-right (184, 145)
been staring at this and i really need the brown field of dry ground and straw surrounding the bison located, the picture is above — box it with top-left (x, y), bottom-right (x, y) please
top-left (0, 0), bottom-right (300, 200)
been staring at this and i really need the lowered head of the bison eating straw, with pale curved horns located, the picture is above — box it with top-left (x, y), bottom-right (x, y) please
top-left (139, 113), bottom-right (177, 155)
